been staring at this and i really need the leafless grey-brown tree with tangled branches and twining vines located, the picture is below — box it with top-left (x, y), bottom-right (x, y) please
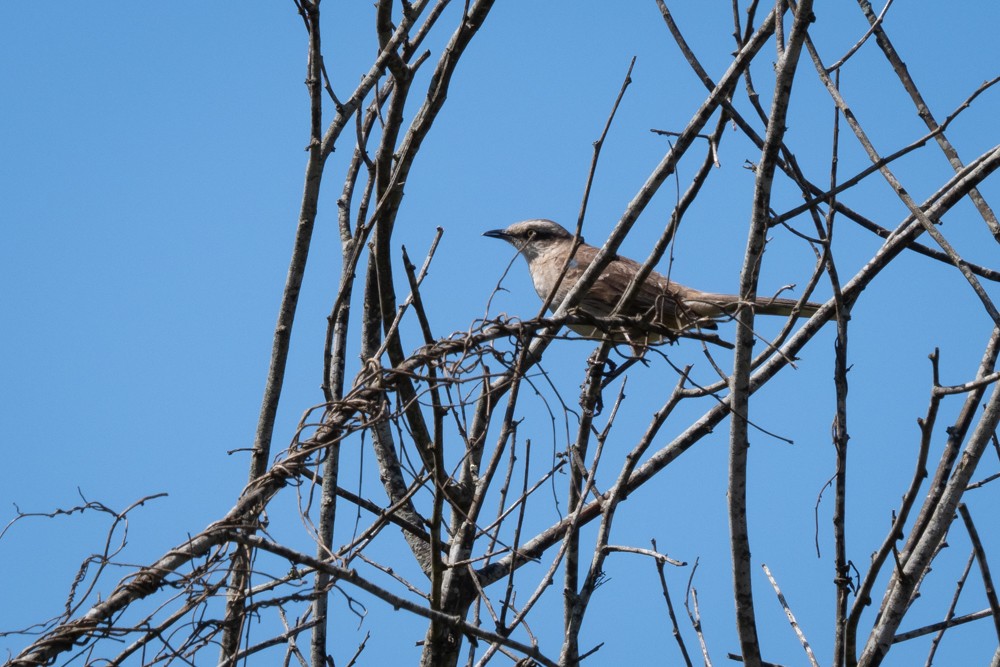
top-left (8, 0), bottom-right (1000, 667)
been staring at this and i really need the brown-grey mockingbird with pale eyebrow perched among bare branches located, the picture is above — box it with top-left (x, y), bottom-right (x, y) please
top-left (483, 220), bottom-right (820, 345)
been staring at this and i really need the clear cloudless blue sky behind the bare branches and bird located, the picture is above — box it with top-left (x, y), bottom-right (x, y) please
top-left (0, 0), bottom-right (1000, 665)
